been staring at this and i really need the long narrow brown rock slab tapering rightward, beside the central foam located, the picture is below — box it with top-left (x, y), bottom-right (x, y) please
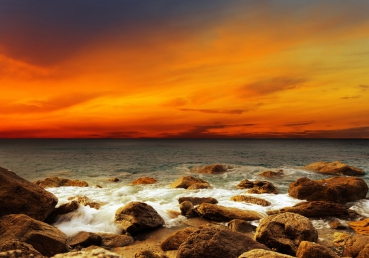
top-left (194, 203), bottom-right (262, 221)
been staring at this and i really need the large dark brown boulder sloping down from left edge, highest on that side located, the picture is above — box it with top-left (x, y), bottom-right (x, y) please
top-left (0, 168), bottom-right (58, 221)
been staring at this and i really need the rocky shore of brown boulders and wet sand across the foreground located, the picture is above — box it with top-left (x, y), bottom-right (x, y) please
top-left (0, 162), bottom-right (369, 258)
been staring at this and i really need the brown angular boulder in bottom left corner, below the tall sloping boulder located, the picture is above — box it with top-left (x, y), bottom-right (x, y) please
top-left (0, 214), bottom-right (68, 257)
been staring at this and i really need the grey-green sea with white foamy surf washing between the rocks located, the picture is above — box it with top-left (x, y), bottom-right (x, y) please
top-left (0, 139), bottom-right (369, 237)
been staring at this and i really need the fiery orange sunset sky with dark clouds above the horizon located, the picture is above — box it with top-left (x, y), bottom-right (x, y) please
top-left (0, 0), bottom-right (369, 138)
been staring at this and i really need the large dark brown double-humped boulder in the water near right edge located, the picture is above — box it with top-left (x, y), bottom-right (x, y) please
top-left (288, 177), bottom-right (368, 203)
